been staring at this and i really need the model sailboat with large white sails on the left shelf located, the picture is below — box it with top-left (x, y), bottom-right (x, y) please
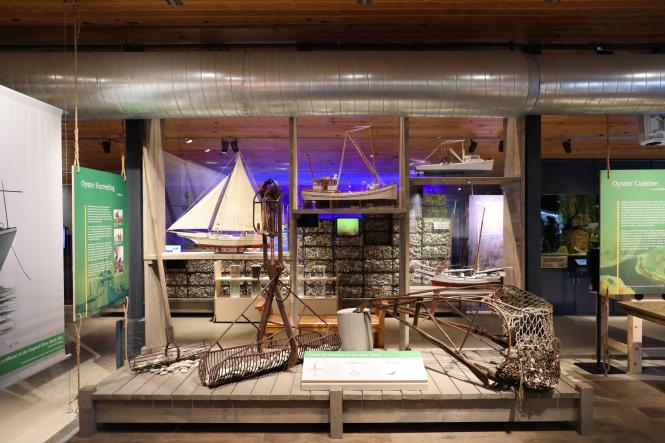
top-left (167, 154), bottom-right (263, 250)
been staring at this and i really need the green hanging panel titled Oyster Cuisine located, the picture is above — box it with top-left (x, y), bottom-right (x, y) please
top-left (599, 169), bottom-right (665, 296)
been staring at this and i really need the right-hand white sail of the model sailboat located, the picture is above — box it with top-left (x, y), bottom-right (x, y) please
top-left (212, 155), bottom-right (258, 232)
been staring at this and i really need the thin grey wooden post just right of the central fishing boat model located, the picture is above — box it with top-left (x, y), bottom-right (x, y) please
top-left (399, 117), bottom-right (411, 350)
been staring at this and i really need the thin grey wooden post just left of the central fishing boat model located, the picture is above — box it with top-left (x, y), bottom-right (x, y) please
top-left (289, 117), bottom-right (298, 327)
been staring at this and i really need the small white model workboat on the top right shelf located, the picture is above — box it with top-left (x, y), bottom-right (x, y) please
top-left (416, 140), bottom-right (494, 176)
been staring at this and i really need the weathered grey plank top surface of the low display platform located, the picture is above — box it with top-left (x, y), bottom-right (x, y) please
top-left (93, 351), bottom-right (576, 401)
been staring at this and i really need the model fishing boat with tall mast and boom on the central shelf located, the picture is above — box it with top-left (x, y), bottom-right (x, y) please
top-left (302, 125), bottom-right (397, 201)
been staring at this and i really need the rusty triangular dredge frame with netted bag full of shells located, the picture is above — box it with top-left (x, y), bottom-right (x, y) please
top-left (356, 285), bottom-right (560, 390)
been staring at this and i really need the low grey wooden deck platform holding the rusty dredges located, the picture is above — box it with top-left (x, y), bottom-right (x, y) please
top-left (79, 350), bottom-right (593, 438)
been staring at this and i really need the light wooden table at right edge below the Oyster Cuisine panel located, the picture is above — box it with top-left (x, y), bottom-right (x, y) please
top-left (612, 300), bottom-right (665, 374)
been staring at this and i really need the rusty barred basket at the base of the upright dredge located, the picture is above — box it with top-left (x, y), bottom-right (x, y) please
top-left (199, 329), bottom-right (342, 388)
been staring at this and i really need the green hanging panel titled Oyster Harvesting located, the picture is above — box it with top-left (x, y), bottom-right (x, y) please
top-left (72, 167), bottom-right (129, 319)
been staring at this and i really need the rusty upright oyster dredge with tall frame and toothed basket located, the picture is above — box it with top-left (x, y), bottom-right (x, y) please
top-left (199, 180), bottom-right (341, 388)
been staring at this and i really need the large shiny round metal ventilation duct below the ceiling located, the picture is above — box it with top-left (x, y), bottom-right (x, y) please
top-left (0, 51), bottom-right (665, 119)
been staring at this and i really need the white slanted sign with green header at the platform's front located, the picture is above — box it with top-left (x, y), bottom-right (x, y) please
top-left (302, 351), bottom-right (427, 390)
